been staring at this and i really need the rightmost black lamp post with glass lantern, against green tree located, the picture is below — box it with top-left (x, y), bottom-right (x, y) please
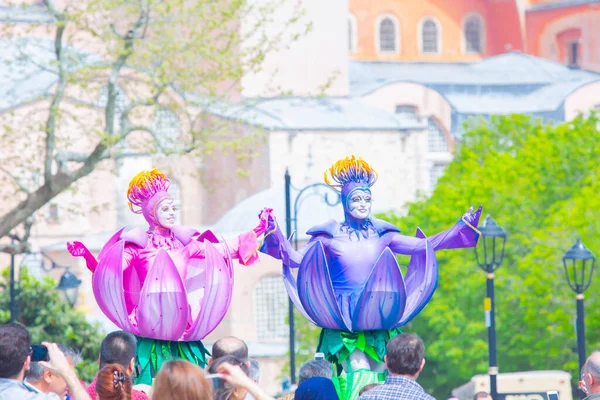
top-left (563, 239), bottom-right (596, 386)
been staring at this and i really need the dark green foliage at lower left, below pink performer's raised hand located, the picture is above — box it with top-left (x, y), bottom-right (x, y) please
top-left (0, 269), bottom-right (103, 383)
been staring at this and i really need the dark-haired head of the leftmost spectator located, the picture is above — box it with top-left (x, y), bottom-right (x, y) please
top-left (0, 323), bottom-right (31, 381)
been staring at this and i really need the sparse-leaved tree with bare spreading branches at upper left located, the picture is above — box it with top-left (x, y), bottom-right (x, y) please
top-left (0, 0), bottom-right (310, 254)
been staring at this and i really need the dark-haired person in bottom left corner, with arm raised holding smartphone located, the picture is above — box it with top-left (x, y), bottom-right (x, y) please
top-left (0, 323), bottom-right (91, 400)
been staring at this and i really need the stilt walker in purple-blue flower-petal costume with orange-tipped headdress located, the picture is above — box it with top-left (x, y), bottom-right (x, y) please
top-left (262, 156), bottom-right (481, 399)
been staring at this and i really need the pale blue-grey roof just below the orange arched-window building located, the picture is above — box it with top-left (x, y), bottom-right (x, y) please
top-left (350, 52), bottom-right (600, 114)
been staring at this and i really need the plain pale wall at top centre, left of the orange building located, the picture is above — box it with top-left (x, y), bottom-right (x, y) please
top-left (242, 0), bottom-right (348, 97)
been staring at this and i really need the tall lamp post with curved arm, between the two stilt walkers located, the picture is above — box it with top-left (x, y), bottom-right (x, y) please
top-left (285, 169), bottom-right (341, 384)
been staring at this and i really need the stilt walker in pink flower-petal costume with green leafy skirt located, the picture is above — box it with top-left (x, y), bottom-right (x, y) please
top-left (67, 169), bottom-right (270, 384)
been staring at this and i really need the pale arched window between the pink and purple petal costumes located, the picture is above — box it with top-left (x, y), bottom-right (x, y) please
top-left (254, 275), bottom-right (289, 340)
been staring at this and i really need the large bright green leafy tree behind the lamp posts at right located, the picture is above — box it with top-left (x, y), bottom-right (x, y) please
top-left (386, 115), bottom-right (600, 397)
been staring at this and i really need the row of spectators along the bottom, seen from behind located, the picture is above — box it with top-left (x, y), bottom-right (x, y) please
top-left (0, 323), bottom-right (580, 400)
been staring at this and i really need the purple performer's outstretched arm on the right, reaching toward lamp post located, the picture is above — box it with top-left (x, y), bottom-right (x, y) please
top-left (386, 206), bottom-right (481, 255)
